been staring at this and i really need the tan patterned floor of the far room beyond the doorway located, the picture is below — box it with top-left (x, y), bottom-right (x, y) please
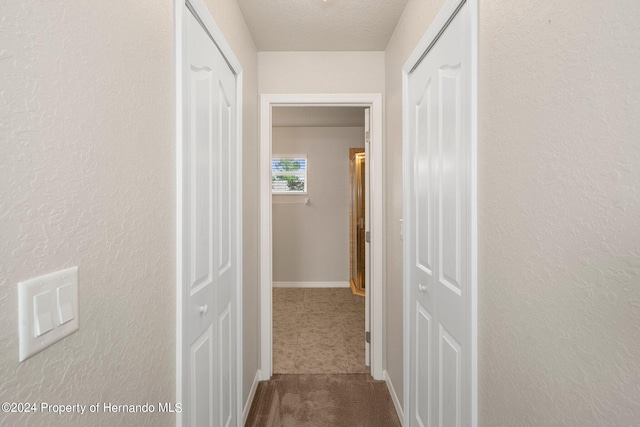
top-left (273, 288), bottom-right (369, 374)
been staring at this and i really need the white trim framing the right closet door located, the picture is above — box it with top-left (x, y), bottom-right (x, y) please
top-left (402, 0), bottom-right (478, 427)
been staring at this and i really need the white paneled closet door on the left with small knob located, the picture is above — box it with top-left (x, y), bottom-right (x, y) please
top-left (181, 7), bottom-right (239, 427)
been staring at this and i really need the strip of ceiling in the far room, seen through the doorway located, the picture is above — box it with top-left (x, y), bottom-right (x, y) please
top-left (271, 107), bottom-right (364, 127)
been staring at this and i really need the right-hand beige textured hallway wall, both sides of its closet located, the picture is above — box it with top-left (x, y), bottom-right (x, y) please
top-left (386, 0), bottom-right (640, 426)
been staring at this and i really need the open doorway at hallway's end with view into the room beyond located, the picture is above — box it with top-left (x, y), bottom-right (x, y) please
top-left (271, 106), bottom-right (370, 374)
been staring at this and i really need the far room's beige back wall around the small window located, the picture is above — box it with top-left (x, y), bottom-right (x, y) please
top-left (272, 127), bottom-right (364, 282)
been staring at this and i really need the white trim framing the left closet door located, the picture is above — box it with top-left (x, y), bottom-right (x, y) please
top-left (174, 0), bottom-right (244, 427)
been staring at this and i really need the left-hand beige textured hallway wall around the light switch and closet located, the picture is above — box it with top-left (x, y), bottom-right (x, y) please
top-left (0, 0), bottom-right (258, 426)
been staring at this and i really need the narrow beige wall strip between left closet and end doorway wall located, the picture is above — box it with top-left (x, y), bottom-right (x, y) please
top-left (200, 0), bottom-right (260, 403)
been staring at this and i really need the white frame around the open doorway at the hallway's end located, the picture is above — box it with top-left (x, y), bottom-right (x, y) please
top-left (260, 93), bottom-right (385, 381)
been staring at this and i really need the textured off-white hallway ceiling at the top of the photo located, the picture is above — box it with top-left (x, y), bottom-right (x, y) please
top-left (238, 0), bottom-right (407, 52)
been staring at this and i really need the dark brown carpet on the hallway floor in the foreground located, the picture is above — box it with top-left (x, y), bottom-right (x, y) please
top-left (245, 374), bottom-right (401, 427)
